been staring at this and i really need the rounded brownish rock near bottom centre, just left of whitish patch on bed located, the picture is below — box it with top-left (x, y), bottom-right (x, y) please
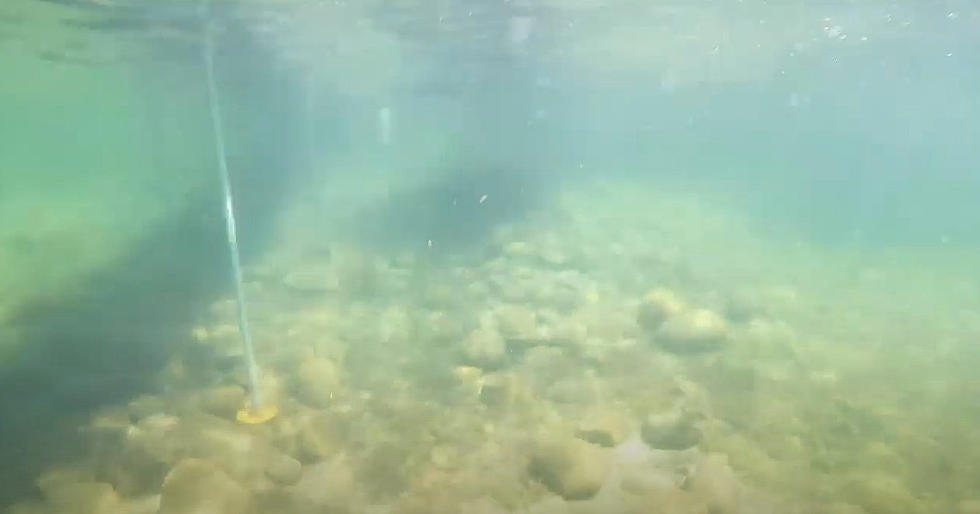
top-left (528, 437), bottom-right (611, 500)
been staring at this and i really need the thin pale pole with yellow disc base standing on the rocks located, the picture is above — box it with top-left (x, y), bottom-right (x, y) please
top-left (202, 0), bottom-right (279, 424)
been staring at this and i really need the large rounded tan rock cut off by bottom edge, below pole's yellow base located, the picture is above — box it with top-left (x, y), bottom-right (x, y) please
top-left (158, 458), bottom-right (252, 514)
